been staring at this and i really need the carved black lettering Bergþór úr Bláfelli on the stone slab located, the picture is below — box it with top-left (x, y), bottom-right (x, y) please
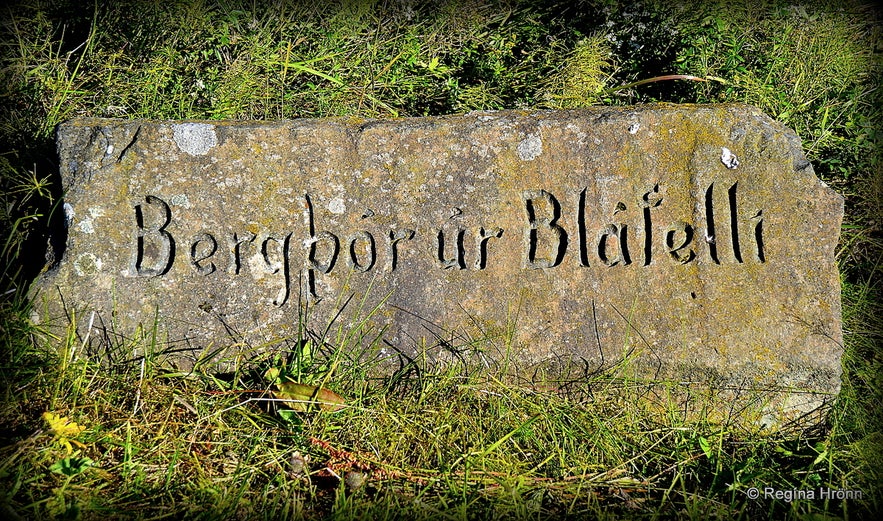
top-left (129, 183), bottom-right (766, 306)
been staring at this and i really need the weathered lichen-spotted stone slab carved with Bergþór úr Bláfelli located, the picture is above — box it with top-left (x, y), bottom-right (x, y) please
top-left (34, 105), bottom-right (843, 424)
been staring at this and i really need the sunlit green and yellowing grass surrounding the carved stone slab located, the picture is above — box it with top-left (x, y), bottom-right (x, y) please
top-left (0, 1), bottom-right (883, 519)
